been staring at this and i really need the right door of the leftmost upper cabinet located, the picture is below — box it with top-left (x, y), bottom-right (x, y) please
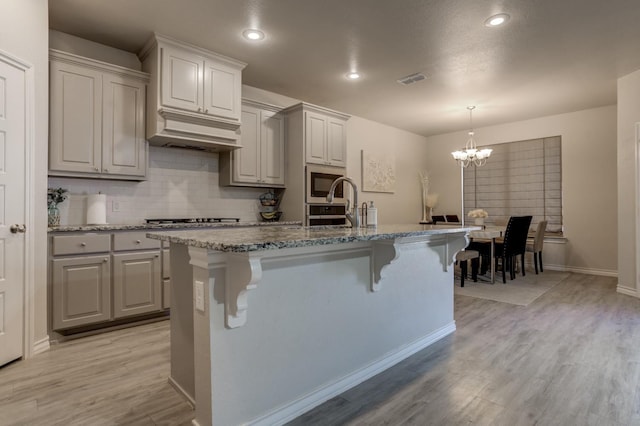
top-left (102, 74), bottom-right (147, 176)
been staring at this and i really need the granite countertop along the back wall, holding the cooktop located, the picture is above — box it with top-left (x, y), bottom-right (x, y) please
top-left (47, 221), bottom-right (301, 232)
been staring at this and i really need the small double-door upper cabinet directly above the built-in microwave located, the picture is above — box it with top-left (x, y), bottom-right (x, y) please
top-left (286, 103), bottom-right (349, 167)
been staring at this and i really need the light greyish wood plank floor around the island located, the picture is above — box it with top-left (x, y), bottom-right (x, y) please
top-left (0, 274), bottom-right (640, 426)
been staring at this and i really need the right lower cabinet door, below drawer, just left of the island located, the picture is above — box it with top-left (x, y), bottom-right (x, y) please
top-left (113, 250), bottom-right (162, 318)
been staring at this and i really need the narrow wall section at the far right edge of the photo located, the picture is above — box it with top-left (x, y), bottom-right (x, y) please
top-left (617, 71), bottom-right (640, 296)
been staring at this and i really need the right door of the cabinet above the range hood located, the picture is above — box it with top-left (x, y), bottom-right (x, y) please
top-left (204, 60), bottom-right (242, 121)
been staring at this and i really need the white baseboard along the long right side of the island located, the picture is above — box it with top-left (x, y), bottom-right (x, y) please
top-left (246, 321), bottom-right (456, 426)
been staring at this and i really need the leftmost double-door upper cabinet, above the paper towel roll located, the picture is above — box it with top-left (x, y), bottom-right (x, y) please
top-left (49, 50), bottom-right (149, 180)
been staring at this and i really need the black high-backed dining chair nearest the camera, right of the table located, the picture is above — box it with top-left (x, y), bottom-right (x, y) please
top-left (494, 216), bottom-right (533, 284)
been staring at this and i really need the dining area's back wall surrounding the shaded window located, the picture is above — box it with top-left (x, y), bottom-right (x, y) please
top-left (427, 106), bottom-right (618, 275)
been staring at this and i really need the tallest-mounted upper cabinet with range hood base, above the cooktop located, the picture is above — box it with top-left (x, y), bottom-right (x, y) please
top-left (140, 34), bottom-right (246, 151)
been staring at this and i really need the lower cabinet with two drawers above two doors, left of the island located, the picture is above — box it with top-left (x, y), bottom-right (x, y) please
top-left (49, 231), bottom-right (169, 332)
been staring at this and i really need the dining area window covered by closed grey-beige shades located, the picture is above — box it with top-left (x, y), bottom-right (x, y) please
top-left (464, 136), bottom-right (562, 232)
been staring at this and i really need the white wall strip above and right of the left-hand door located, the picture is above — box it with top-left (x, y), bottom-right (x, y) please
top-left (0, 0), bottom-right (49, 352)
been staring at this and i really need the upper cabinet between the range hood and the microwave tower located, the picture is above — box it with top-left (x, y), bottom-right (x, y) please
top-left (220, 100), bottom-right (285, 188)
